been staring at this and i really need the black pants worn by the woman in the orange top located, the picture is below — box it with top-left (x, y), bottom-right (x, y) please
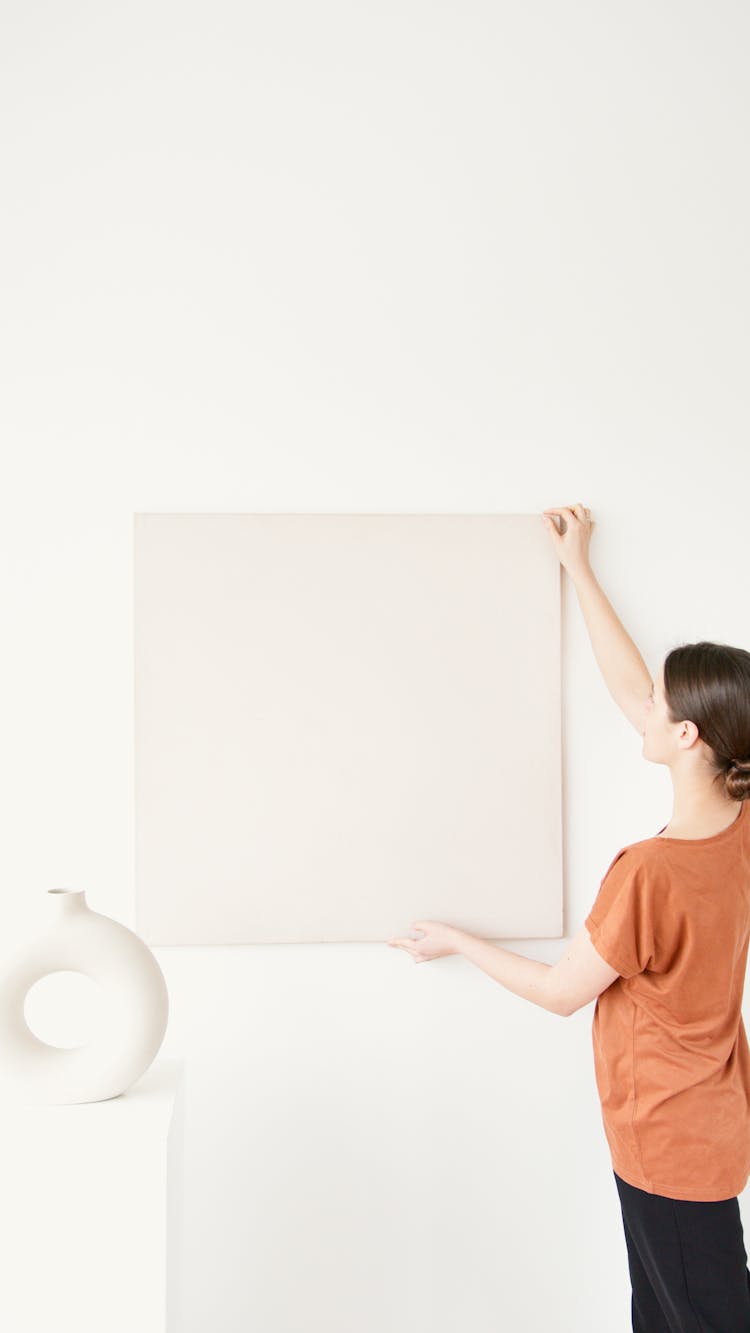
top-left (613, 1172), bottom-right (750, 1333)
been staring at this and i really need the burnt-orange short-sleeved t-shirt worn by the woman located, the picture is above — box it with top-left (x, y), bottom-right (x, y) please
top-left (585, 801), bottom-right (750, 1202)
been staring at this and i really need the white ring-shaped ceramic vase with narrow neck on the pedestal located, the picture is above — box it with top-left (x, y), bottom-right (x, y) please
top-left (0, 889), bottom-right (169, 1105)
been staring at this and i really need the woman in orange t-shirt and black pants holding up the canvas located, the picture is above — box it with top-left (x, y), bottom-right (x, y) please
top-left (389, 504), bottom-right (750, 1333)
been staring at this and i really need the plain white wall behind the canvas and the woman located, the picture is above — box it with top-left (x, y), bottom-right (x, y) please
top-left (0, 0), bottom-right (750, 1333)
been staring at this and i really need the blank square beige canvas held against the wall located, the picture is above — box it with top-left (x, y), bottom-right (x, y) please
top-left (133, 513), bottom-right (562, 944)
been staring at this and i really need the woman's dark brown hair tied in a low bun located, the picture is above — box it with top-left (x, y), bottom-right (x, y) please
top-left (663, 641), bottom-right (750, 801)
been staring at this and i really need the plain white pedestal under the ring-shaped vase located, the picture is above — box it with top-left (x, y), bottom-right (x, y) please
top-left (0, 1058), bottom-right (185, 1333)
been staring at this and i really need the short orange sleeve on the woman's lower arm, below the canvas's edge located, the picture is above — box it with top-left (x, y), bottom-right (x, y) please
top-left (583, 846), bottom-right (654, 977)
